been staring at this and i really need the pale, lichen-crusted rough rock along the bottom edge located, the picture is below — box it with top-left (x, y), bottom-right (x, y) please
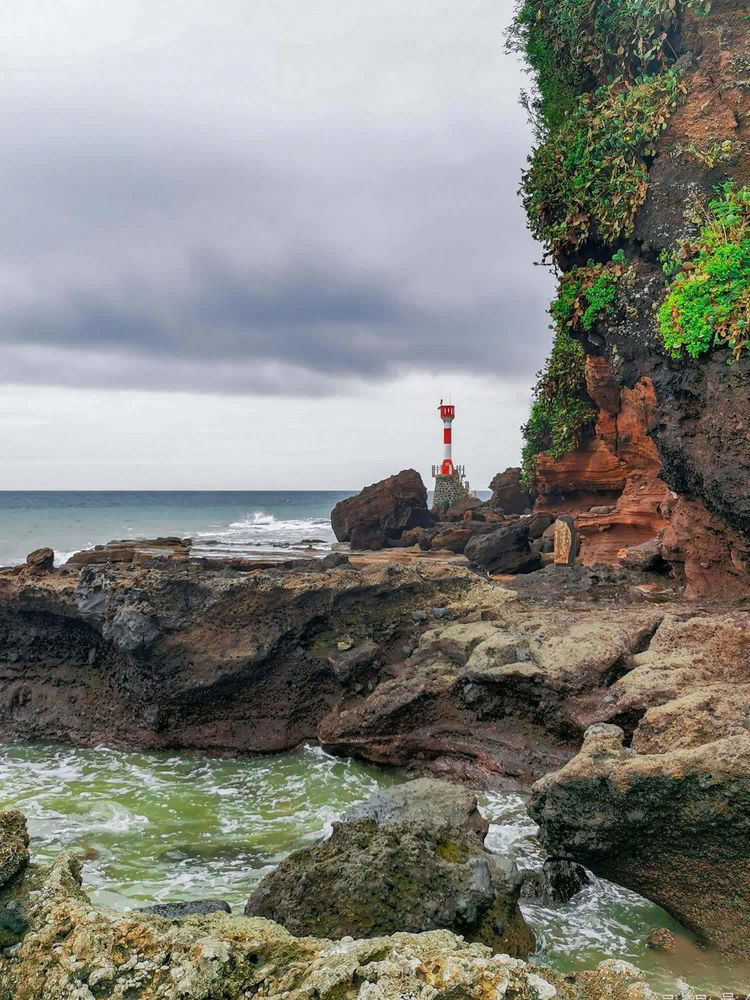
top-left (0, 820), bottom-right (668, 1000)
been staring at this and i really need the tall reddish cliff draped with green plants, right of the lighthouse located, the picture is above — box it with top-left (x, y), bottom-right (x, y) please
top-left (512, 0), bottom-right (750, 597)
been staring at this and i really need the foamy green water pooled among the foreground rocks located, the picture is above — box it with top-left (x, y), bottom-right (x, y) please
top-left (0, 744), bottom-right (750, 1000)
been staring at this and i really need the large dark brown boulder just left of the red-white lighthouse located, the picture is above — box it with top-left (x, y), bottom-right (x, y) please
top-left (331, 469), bottom-right (432, 549)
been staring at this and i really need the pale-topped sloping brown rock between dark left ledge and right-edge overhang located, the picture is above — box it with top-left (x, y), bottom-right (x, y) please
top-left (318, 574), bottom-right (664, 785)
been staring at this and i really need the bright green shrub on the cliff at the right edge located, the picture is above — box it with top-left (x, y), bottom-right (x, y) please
top-left (659, 184), bottom-right (750, 358)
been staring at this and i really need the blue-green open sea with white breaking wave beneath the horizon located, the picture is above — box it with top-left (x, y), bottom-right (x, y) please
top-left (0, 490), bottom-right (352, 566)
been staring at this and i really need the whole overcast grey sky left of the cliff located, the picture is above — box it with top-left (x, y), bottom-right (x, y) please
top-left (0, 0), bottom-right (552, 489)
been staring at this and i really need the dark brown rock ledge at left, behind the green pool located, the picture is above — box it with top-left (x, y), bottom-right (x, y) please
top-left (0, 560), bottom-right (474, 752)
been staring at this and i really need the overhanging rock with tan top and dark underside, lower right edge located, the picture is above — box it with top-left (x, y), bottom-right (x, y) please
top-left (529, 725), bottom-right (750, 959)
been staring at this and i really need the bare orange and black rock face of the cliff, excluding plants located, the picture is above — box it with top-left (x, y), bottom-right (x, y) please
top-left (524, 0), bottom-right (750, 600)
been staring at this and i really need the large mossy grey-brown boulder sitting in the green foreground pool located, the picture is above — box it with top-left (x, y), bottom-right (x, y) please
top-left (245, 778), bottom-right (534, 957)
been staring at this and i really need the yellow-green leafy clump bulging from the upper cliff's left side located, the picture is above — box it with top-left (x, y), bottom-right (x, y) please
top-left (522, 70), bottom-right (684, 253)
